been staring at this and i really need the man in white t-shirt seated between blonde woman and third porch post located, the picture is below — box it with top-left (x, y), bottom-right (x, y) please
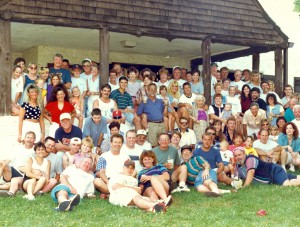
top-left (178, 82), bottom-right (196, 128)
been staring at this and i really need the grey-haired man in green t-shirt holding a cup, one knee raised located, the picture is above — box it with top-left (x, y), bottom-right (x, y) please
top-left (153, 133), bottom-right (190, 193)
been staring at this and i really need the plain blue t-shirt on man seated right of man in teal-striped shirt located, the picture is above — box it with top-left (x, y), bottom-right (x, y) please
top-left (193, 147), bottom-right (222, 169)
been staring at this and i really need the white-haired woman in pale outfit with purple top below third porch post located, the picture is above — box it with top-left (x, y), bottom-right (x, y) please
top-left (190, 95), bottom-right (209, 141)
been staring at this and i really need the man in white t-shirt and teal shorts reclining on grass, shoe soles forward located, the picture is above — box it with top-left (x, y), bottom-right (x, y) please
top-left (51, 157), bottom-right (95, 211)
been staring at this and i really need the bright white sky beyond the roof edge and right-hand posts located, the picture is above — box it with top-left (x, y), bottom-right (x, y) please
top-left (219, 0), bottom-right (300, 84)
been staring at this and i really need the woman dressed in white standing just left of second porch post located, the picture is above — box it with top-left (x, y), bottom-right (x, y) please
top-left (86, 66), bottom-right (100, 116)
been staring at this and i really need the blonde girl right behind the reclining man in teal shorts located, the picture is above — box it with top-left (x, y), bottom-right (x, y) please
top-left (74, 136), bottom-right (98, 172)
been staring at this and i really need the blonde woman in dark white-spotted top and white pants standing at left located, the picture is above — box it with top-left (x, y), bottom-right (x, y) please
top-left (18, 84), bottom-right (45, 143)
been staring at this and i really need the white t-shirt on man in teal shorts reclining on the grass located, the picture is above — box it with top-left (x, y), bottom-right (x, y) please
top-left (61, 165), bottom-right (95, 198)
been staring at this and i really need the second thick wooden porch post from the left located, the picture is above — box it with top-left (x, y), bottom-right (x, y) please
top-left (99, 27), bottom-right (109, 87)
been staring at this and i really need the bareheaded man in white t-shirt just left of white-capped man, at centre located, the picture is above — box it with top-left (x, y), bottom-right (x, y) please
top-left (120, 130), bottom-right (143, 174)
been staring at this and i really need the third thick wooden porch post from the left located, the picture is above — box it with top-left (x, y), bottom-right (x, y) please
top-left (201, 39), bottom-right (211, 105)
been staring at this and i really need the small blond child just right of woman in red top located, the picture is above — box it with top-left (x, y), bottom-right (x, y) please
top-left (70, 86), bottom-right (84, 129)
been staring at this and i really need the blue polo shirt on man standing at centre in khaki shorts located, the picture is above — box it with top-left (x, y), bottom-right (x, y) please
top-left (137, 98), bottom-right (165, 121)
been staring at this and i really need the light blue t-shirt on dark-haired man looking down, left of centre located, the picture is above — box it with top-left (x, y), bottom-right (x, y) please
top-left (83, 116), bottom-right (107, 146)
